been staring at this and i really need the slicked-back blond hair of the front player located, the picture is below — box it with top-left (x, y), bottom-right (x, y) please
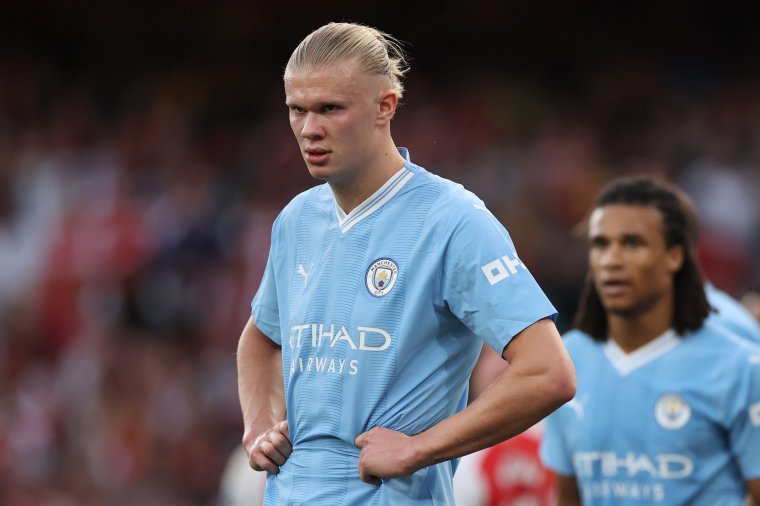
top-left (285, 23), bottom-right (409, 100)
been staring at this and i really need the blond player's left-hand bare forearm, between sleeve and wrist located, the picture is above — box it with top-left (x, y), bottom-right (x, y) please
top-left (237, 318), bottom-right (285, 438)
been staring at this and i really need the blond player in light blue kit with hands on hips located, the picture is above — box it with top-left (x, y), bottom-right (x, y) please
top-left (238, 23), bottom-right (575, 505)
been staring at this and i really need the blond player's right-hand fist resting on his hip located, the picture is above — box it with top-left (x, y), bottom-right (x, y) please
top-left (354, 427), bottom-right (422, 485)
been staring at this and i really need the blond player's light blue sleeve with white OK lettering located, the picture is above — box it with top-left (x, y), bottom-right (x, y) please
top-left (442, 199), bottom-right (557, 353)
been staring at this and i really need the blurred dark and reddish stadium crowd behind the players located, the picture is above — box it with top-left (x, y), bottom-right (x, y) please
top-left (0, 0), bottom-right (760, 506)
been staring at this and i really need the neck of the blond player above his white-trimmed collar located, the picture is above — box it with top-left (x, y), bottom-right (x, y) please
top-left (329, 144), bottom-right (406, 214)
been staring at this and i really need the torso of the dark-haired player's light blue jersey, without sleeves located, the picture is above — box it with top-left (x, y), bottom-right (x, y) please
top-left (562, 338), bottom-right (741, 505)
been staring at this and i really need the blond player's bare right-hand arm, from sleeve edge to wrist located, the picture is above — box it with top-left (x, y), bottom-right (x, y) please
top-left (414, 324), bottom-right (575, 467)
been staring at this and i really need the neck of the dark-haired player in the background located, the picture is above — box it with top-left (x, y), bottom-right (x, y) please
top-left (607, 298), bottom-right (673, 353)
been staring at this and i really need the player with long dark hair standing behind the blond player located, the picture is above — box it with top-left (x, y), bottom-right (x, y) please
top-left (541, 177), bottom-right (760, 506)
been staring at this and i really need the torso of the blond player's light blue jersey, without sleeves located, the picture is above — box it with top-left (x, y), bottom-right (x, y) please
top-left (270, 176), bottom-right (470, 504)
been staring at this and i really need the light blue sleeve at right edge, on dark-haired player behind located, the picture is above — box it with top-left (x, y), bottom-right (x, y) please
top-left (729, 346), bottom-right (760, 479)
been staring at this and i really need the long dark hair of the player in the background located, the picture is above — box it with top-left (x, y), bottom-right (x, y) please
top-left (574, 176), bottom-right (711, 341)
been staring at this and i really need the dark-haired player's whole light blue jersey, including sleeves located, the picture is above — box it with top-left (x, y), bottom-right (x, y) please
top-left (541, 323), bottom-right (760, 506)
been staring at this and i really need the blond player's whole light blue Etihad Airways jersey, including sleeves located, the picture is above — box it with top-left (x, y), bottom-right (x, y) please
top-left (252, 151), bottom-right (556, 505)
